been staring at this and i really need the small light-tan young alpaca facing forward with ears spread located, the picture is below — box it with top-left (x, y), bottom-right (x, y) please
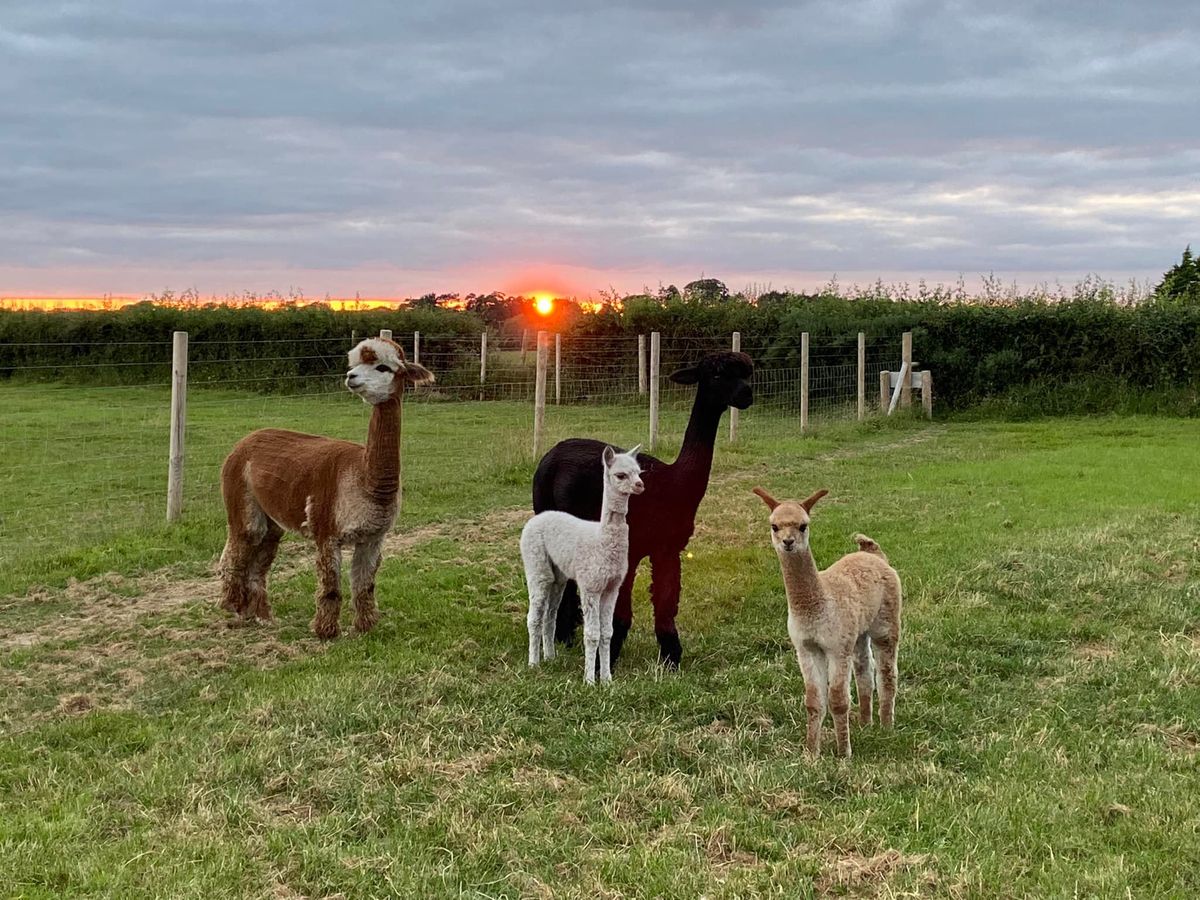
top-left (754, 487), bottom-right (901, 756)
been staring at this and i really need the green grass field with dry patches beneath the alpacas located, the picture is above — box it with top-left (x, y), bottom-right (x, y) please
top-left (0, 388), bottom-right (1200, 898)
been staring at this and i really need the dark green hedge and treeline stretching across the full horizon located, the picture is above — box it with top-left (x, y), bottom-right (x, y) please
top-left (0, 286), bottom-right (1200, 416)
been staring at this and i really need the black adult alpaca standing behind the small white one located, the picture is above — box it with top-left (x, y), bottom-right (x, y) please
top-left (533, 352), bottom-right (754, 668)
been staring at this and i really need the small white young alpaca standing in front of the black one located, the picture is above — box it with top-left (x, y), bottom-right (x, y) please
top-left (521, 445), bottom-right (644, 684)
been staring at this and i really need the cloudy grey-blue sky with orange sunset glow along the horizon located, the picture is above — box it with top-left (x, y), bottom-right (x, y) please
top-left (0, 0), bottom-right (1200, 296)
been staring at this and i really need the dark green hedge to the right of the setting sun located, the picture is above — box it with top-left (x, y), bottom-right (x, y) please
top-left (578, 294), bottom-right (1200, 415)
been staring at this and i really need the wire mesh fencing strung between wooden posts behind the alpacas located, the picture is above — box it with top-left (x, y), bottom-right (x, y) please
top-left (0, 332), bottom-right (916, 580)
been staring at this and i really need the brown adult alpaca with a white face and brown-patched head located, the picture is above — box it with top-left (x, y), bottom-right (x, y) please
top-left (218, 337), bottom-right (433, 640)
